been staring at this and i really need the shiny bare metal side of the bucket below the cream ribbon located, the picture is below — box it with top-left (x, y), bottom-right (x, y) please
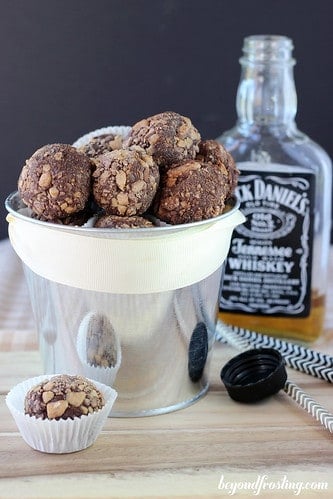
top-left (25, 266), bottom-right (221, 416)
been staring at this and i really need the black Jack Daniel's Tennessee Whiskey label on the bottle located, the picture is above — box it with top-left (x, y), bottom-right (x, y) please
top-left (220, 163), bottom-right (315, 317)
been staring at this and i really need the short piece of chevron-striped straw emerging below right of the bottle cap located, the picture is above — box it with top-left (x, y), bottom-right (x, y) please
top-left (284, 381), bottom-right (333, 433)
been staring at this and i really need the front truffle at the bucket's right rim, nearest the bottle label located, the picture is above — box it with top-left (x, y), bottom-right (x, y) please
top-left (154, 160), bottom-right (229, 224)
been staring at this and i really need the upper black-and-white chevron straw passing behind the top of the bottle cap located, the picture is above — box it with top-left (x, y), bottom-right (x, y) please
top-left (216, 321), bottom-right (333, 383)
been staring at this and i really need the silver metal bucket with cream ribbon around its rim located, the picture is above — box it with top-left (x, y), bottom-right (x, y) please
top-left (6, 193), bottom-right (244, 417)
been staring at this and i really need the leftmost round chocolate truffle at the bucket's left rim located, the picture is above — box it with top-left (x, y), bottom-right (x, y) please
top-left (18, 144), bottom-right (91, 220)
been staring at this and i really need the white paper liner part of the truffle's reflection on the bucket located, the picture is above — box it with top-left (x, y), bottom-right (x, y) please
top-left (76, 312), bottom-right (121, 385)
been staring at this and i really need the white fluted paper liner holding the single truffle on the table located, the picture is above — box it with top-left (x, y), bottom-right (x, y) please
top-left (6, 375), bottom-right (117, 454)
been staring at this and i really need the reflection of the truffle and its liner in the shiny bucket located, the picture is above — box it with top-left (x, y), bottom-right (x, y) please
top-left (77, 312), bottom-right (121, 385)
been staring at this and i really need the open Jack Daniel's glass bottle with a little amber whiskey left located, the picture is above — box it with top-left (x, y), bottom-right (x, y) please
top-left (217, 35), bottom-right (332, 341)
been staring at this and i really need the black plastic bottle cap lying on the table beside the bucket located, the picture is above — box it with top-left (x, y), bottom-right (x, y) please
top-left (221, 348), bottom-right (287, 402)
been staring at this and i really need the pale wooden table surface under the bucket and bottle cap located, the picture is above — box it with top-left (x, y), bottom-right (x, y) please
top-left (0, 253), bottom-right (333, 498)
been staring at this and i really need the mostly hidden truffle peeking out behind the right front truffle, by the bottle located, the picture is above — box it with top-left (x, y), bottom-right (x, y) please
top-left (196, 140), bottom-right (239, 198)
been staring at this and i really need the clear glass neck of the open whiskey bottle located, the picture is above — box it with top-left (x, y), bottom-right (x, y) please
top-left (236, 35), bottom-right (297, 127)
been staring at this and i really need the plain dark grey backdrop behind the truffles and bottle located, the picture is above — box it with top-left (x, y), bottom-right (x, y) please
top-left (0, 0), bottom-right (333, 238)
